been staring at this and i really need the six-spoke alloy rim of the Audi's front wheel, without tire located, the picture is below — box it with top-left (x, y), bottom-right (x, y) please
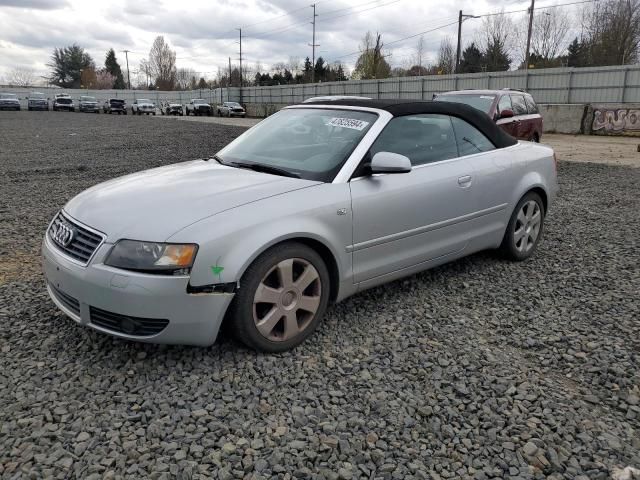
top-left (253, 258), bottom-right (322, 342)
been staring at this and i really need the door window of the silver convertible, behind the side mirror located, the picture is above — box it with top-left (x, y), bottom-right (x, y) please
top-left (369, 114), bottom-right (458, 166)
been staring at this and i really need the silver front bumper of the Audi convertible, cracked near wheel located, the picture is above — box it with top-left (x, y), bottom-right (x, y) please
top-left (42, 235), bottom-right (233, 346)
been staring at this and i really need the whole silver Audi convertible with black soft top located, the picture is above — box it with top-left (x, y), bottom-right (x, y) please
top-left (42, 99), bottom-right (557, 352)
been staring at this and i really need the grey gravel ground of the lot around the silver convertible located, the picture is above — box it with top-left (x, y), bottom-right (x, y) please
top-left (0, 112), bottom-right (640, 480)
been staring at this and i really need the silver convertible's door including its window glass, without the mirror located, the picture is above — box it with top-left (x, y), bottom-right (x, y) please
top-left (350, 114), bottom-right (475, 286)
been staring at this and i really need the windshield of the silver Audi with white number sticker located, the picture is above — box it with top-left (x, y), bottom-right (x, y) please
top-left (218, 108), bottom-right (377, 182)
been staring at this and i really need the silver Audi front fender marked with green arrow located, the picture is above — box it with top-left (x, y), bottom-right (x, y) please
top-left (168, 183), bottom-right (352, 286)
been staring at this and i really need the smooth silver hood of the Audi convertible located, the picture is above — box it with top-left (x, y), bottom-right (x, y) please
top-left (64, 160), bottom-right (320, 242)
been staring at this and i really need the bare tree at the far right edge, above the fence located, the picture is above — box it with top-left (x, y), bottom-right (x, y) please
top-left (583, 0), bottom-right (640, 65)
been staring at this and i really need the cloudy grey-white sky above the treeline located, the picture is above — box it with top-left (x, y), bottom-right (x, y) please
top-left (0, 0), bottom-right (580, 83)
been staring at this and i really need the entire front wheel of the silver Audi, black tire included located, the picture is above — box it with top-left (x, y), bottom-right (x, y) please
top-left (228, 242), bottom-right (330, 353)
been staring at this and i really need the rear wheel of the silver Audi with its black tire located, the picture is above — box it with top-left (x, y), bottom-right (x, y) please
top-left (500, 192), bottom-right (545, 262)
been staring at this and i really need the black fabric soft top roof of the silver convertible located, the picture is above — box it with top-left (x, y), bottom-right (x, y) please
top-left (304, 99), bottom-right (518, 148)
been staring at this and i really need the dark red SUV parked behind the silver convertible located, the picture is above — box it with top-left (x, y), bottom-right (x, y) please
top-left (434, 89), bottom-right (542, 142)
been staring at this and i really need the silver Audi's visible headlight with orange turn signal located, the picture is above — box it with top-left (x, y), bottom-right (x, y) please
top-left (104, 240), bottom-right (198, 275)
